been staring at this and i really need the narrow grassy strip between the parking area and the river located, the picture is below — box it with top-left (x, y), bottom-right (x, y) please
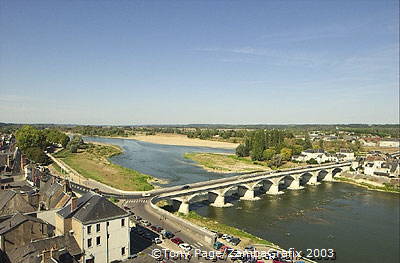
top-left (178, 211), bottom-right (276, 247)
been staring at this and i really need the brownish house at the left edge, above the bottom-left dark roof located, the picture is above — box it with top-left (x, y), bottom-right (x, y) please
top-left (0, 213), bottom-right (54, 254)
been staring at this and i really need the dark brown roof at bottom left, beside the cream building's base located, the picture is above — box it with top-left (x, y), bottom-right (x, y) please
top-left (8, 235), bottom-right (82, 263)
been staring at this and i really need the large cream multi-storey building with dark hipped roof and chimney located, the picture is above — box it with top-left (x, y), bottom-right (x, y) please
top-left (56, 193), bottom-right (130, 263)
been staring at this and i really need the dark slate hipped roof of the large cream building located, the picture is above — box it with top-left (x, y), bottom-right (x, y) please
top-left (57, 193), bottom-right (129, 224)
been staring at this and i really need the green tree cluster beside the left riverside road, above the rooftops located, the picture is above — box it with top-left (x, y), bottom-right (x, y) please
top-left (15, 125), bottom-right (69, 163)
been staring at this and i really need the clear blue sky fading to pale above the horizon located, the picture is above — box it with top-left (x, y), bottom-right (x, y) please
top-left (0, 0), bottom-right (399, 125)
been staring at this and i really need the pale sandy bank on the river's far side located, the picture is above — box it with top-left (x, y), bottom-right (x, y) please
top-left (104, 134), bottom-right (239, 149)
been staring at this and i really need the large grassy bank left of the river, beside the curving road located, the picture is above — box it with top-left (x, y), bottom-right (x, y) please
top-left (55, 144), bottom-right (154, 191)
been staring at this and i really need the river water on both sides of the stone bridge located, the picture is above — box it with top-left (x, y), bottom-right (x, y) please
top-left (86, 137), bottom-right (400, 263)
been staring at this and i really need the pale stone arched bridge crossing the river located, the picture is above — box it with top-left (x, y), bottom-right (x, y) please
top-left (158, 162), bottom-right (351, 214)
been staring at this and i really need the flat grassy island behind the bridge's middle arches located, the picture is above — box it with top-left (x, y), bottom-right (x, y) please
top-left (184, 153), bottom-right (269, 173)
